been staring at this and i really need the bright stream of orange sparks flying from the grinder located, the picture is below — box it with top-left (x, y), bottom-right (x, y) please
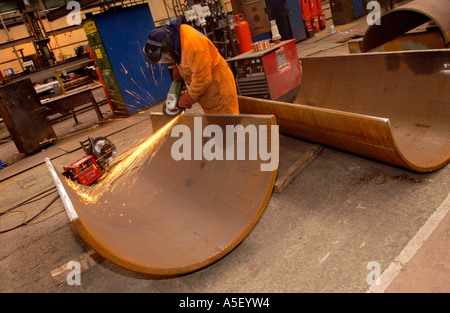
top-left (67, 116), bottom-right (179, 204)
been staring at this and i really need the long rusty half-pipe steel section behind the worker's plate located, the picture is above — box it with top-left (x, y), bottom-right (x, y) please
top-left (239, 50), bottom-right (450, 172)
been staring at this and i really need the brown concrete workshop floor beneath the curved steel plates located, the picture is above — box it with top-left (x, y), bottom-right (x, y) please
top-left (0, 10), bottom-right (450, 293)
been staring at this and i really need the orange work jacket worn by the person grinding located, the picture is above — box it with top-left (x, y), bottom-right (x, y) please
top-left (178, 24), bottom-right (239, 114)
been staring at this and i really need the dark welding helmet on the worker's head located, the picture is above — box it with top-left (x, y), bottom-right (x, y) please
top-left (144, 27), bottom-right (176, 64)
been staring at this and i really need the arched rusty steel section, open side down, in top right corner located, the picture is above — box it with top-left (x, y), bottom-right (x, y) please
top-left (362, 0), bottom-right (450, 52)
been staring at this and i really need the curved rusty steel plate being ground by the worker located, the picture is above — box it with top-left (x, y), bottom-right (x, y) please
top-left (47, 114), bottom-right (278, 275)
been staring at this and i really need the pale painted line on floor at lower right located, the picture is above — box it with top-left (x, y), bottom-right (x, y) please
top-left (366, 195), bottom-right (450, 293)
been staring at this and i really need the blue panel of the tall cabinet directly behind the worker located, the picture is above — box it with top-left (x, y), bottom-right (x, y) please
top-left (94, 3), bottom-right (172, 113)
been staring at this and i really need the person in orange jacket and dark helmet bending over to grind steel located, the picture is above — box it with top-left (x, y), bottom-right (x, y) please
top-left (144, 16), bottom-right (239, 114)
